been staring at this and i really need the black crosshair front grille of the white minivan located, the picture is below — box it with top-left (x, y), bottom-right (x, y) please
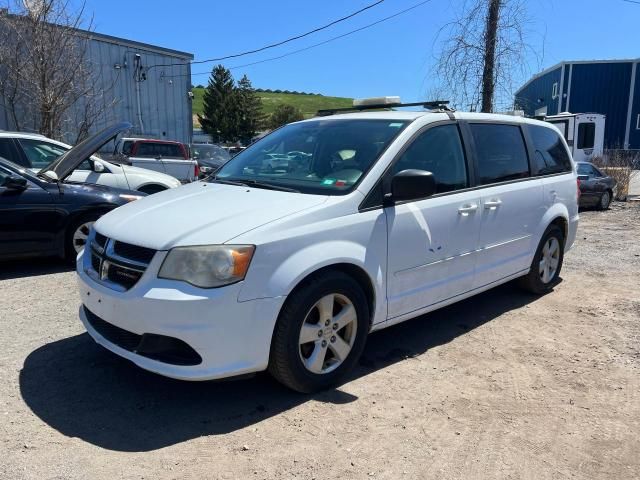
top-left (90, 232), bottom-right (156, 290)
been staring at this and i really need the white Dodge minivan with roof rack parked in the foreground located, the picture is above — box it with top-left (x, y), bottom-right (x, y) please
top-left (77, 99), bottom-right (578, 392)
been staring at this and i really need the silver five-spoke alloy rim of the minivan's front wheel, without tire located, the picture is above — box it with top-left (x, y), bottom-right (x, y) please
top-left (299, 293), bottom-right (358, 374)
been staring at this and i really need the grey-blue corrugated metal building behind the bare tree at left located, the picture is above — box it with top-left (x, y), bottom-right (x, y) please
top-left (0, 26), bottom-right (193, 143)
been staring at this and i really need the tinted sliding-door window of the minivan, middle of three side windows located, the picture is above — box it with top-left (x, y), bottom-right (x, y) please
top-left (470, 123), bottom-right (529, 185)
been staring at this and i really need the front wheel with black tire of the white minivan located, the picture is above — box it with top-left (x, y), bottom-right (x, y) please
top-left (269, 271), bottom-right (370, 393)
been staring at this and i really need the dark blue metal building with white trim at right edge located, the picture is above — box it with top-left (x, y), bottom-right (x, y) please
top-left (514, 58), bottom-right (640, 149)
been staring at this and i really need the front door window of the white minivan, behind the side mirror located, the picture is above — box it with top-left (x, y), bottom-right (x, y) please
top-left (391, 125), bottom-right (469, 193)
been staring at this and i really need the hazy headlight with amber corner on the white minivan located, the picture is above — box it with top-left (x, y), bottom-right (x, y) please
top-left (158, 245), bottom-right (255, 288)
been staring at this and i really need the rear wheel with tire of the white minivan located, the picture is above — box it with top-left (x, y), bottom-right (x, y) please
top-left (519, 225), bottom-right (564, 295)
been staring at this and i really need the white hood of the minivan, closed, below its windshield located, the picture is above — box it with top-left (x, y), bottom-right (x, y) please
top-left (95, 182), bottom-right (328, 250)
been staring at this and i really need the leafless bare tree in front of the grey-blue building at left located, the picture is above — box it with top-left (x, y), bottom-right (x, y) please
top-left (0, 0), bottom-right (115, 139)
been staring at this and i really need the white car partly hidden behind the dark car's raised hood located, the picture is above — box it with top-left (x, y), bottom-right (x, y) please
top-left (0, 131), bottom-right (181, 194)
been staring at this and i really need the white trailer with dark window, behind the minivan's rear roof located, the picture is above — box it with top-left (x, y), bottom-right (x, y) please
top-left (545, 112), bottom-right (606, 162)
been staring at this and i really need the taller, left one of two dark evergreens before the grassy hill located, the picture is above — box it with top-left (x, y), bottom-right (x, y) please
top-left (198, 65), bottom-right (238, 143)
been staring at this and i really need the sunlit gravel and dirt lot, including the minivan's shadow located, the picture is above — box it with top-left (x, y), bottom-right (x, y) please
top-left (0, 203), bottom-right (640, 480)
